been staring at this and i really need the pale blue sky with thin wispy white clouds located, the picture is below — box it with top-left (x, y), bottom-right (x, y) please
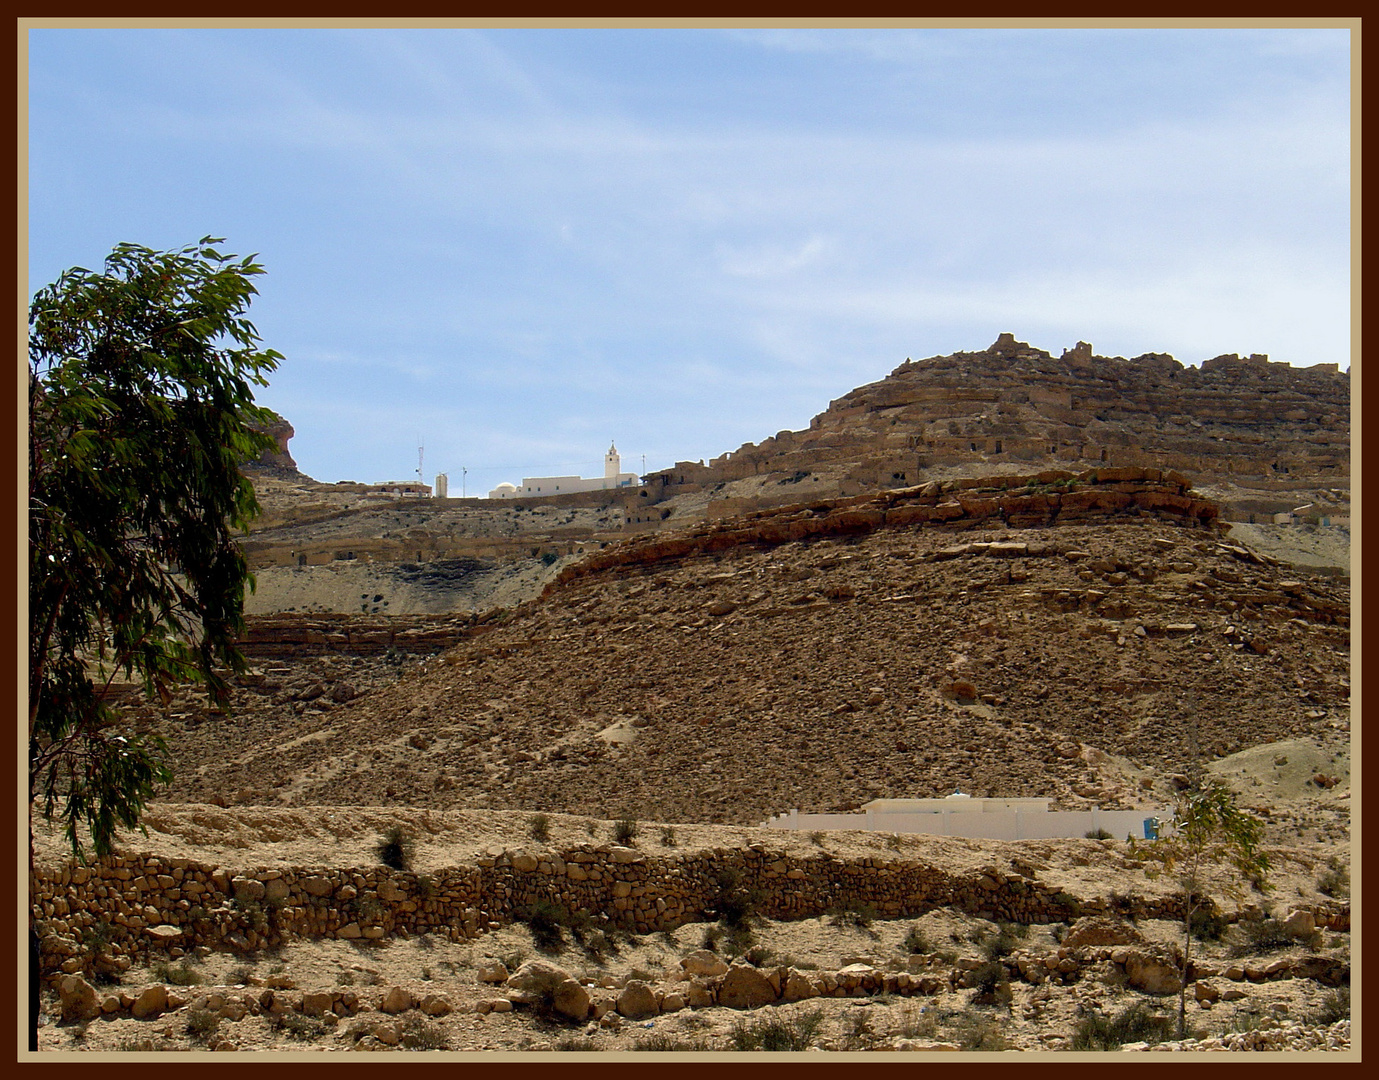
top-left (28, 28), bottom-right (1351, 495)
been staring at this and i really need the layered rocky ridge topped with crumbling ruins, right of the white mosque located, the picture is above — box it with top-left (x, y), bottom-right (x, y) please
top-left (650, 334), bottom-right (1350, 510)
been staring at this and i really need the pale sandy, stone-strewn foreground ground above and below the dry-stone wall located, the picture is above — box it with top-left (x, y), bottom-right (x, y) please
top-left (37, 800), bottom-right (1350, 1052)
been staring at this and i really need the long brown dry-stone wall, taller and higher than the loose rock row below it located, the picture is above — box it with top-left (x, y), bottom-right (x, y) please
top-left (32, 844), bottom-right (1350, 979)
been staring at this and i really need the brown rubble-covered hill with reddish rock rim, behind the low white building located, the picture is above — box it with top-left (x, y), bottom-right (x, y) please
top-left (141, 470), bottom-right (1350, 825)
